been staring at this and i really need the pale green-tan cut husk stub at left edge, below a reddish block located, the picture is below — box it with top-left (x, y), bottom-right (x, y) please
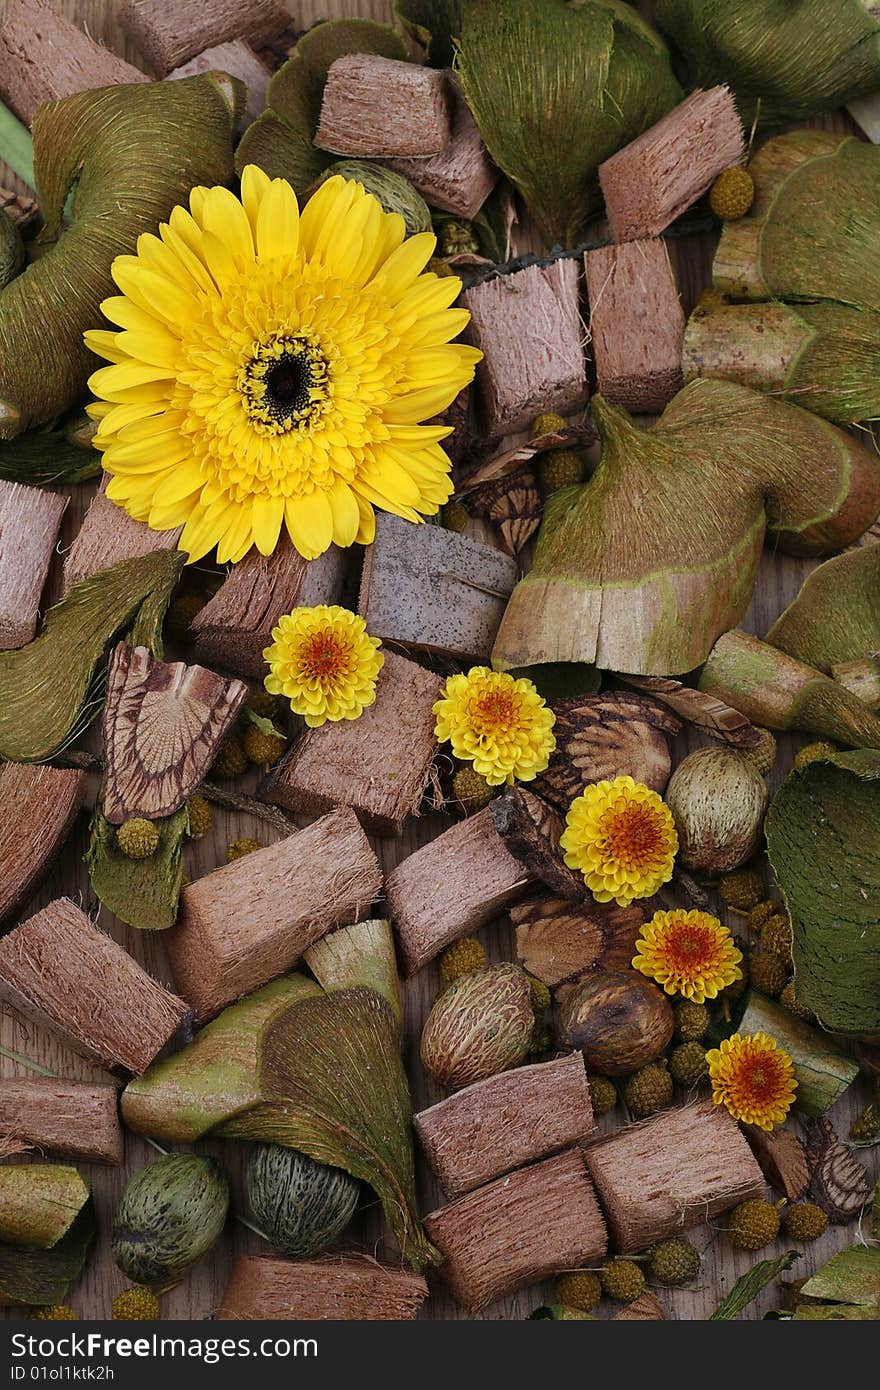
top-left (0, 1163), bottom-right (89, 1250)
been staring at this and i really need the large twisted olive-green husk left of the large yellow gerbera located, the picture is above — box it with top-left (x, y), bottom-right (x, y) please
top-left (0, 74), bottom-right (245, 438)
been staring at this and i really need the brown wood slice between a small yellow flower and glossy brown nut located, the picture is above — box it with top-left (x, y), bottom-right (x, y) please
top-left (510, 892), bottom-right (646, 990)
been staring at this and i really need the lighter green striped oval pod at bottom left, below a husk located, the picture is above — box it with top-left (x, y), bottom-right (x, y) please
top-left (111, 1154), bottom-right (229, 1290)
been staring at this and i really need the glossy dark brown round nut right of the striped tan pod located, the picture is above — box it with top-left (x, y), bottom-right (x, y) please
top-left (559, 970), bottom-right (674, 1076)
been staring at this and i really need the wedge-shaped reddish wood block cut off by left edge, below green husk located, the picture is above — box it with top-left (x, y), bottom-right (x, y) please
top-left (0, 763), bottom-right (88, 922)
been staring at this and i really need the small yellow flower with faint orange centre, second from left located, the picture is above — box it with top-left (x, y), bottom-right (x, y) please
top-left (434, 666), bottom-right (556, 787)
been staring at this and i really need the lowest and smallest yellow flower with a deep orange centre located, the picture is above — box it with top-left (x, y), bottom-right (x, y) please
top-left (706, 1033), bottom-right (798, 1130)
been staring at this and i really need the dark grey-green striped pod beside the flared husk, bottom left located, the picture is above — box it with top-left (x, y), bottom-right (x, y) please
top-left (247, 1144), bottom-right (360, 1259)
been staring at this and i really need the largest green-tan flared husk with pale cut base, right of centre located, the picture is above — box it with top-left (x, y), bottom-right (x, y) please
top-left (492, 381), bottom-right (880, 678)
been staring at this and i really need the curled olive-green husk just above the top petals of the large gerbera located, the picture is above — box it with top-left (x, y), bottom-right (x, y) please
top-left (235, 19), bottom-right (407, 197)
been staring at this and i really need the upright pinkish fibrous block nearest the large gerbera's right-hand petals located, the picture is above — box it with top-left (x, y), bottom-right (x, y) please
top-left (462, 260), bottom-right (588, 435)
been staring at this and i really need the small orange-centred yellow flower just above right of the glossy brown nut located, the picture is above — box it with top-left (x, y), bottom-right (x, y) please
top-left (633, 908), bottom-right (742, 1004)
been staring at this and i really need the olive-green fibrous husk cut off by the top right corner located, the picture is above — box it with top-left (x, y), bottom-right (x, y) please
top-left (653, 0), bottom-right (880, 125)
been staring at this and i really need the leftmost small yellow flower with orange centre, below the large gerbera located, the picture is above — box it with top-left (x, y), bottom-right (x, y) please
top-left (263, 603), bottom-right (385, 728)
